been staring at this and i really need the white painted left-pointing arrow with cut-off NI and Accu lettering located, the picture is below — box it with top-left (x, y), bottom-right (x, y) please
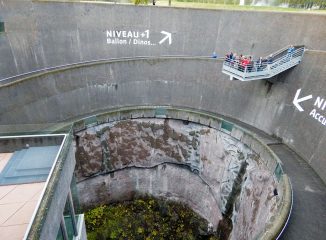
top-left (292, 88), bottom-right (326, 126)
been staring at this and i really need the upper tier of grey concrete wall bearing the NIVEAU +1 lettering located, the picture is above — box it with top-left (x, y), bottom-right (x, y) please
top-left (0, 0), bottom-right (326, 79)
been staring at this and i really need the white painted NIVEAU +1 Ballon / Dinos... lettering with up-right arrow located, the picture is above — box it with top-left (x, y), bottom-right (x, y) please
top-left (105, 29), bottom-right (172, 46)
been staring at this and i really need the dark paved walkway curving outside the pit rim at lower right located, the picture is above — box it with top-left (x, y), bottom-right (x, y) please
top-left (270, 144), bottom-right (326, 240)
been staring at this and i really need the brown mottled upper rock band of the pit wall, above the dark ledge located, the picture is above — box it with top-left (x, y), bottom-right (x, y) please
top-left (76, 119), bottom-right (201, 179)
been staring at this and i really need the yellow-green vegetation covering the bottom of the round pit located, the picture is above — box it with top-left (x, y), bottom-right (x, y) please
top-left (85, 197), bottom-right (218, 240)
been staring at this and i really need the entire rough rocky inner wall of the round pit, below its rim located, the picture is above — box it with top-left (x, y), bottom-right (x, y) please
top-left (75, 119), bottom-right (278, 239)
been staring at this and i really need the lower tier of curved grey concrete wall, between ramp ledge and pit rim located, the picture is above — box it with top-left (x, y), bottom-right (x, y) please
top-left (0, 51), bottom-right (326, 181)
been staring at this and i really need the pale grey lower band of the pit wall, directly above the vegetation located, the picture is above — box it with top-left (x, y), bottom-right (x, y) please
top-left (78, 164), bottom-right (222, 229)
